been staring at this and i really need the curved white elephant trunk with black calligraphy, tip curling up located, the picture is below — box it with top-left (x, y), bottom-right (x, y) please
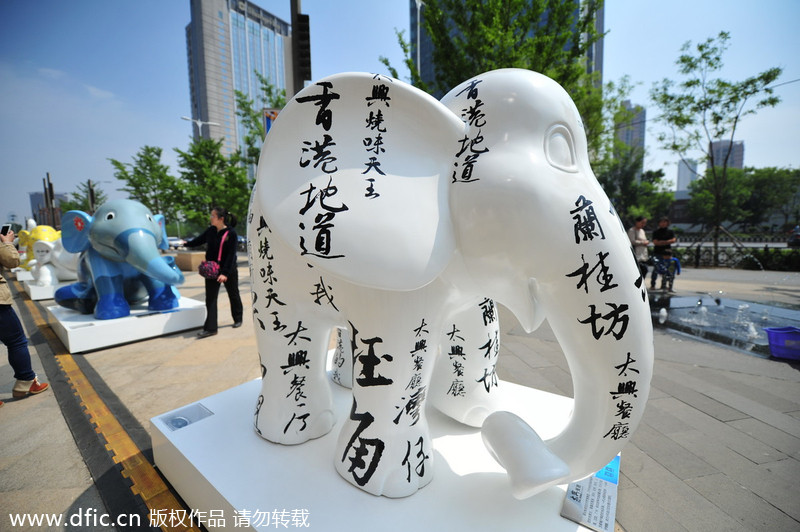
top-left (482, 228), bottom-right (653, 499)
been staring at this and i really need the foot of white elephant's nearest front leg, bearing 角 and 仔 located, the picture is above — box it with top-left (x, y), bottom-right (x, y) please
top-left (335, 418), bottom-right (434, 498)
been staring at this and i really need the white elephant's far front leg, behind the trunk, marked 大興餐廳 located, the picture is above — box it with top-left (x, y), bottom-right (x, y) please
top-left (429, 297), bottom-right (500, 427)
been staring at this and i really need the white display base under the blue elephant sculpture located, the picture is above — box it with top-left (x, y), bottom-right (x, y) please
top-left (47, 297), bottom-right (206, 353)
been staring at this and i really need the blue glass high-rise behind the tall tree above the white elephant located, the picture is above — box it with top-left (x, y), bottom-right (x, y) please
top-left (409, 0), bottom-right (605, 98)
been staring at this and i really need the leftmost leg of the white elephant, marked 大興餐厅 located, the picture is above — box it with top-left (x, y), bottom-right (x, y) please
top-left (254, 302), bottom-right (336, 445)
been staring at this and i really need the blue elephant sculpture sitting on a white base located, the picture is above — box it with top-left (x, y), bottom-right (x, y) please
top-left (55, 200), bottom-right (184, 320)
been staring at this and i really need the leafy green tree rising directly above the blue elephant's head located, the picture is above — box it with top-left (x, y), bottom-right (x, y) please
top-left (109, 146), bottom-right (183, 222)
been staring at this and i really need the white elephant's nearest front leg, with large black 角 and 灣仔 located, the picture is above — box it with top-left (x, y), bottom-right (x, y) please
top-left (334, 295), bottom-right (438, 497)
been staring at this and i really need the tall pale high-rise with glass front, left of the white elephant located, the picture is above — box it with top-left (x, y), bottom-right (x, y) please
top-left (186, 0), bottom-right (294, 154)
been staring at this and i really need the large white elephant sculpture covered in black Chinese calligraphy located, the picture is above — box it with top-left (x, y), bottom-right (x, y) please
top-left (248, 69), bottom-right (653, 498)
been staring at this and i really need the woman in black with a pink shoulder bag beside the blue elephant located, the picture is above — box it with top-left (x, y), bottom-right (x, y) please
top-left (186, 207), bottom-right (243, 338)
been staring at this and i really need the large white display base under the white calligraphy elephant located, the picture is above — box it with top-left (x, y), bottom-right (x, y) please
top-left (150, 379), bottom-right (587, 532)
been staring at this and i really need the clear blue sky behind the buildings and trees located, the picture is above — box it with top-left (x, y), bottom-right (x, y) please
top-left (0, 0), bottom-right (800, 224)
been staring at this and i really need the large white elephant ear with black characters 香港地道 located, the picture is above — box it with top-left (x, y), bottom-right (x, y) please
top-left (255, 72), bottom-right (465, 290)
